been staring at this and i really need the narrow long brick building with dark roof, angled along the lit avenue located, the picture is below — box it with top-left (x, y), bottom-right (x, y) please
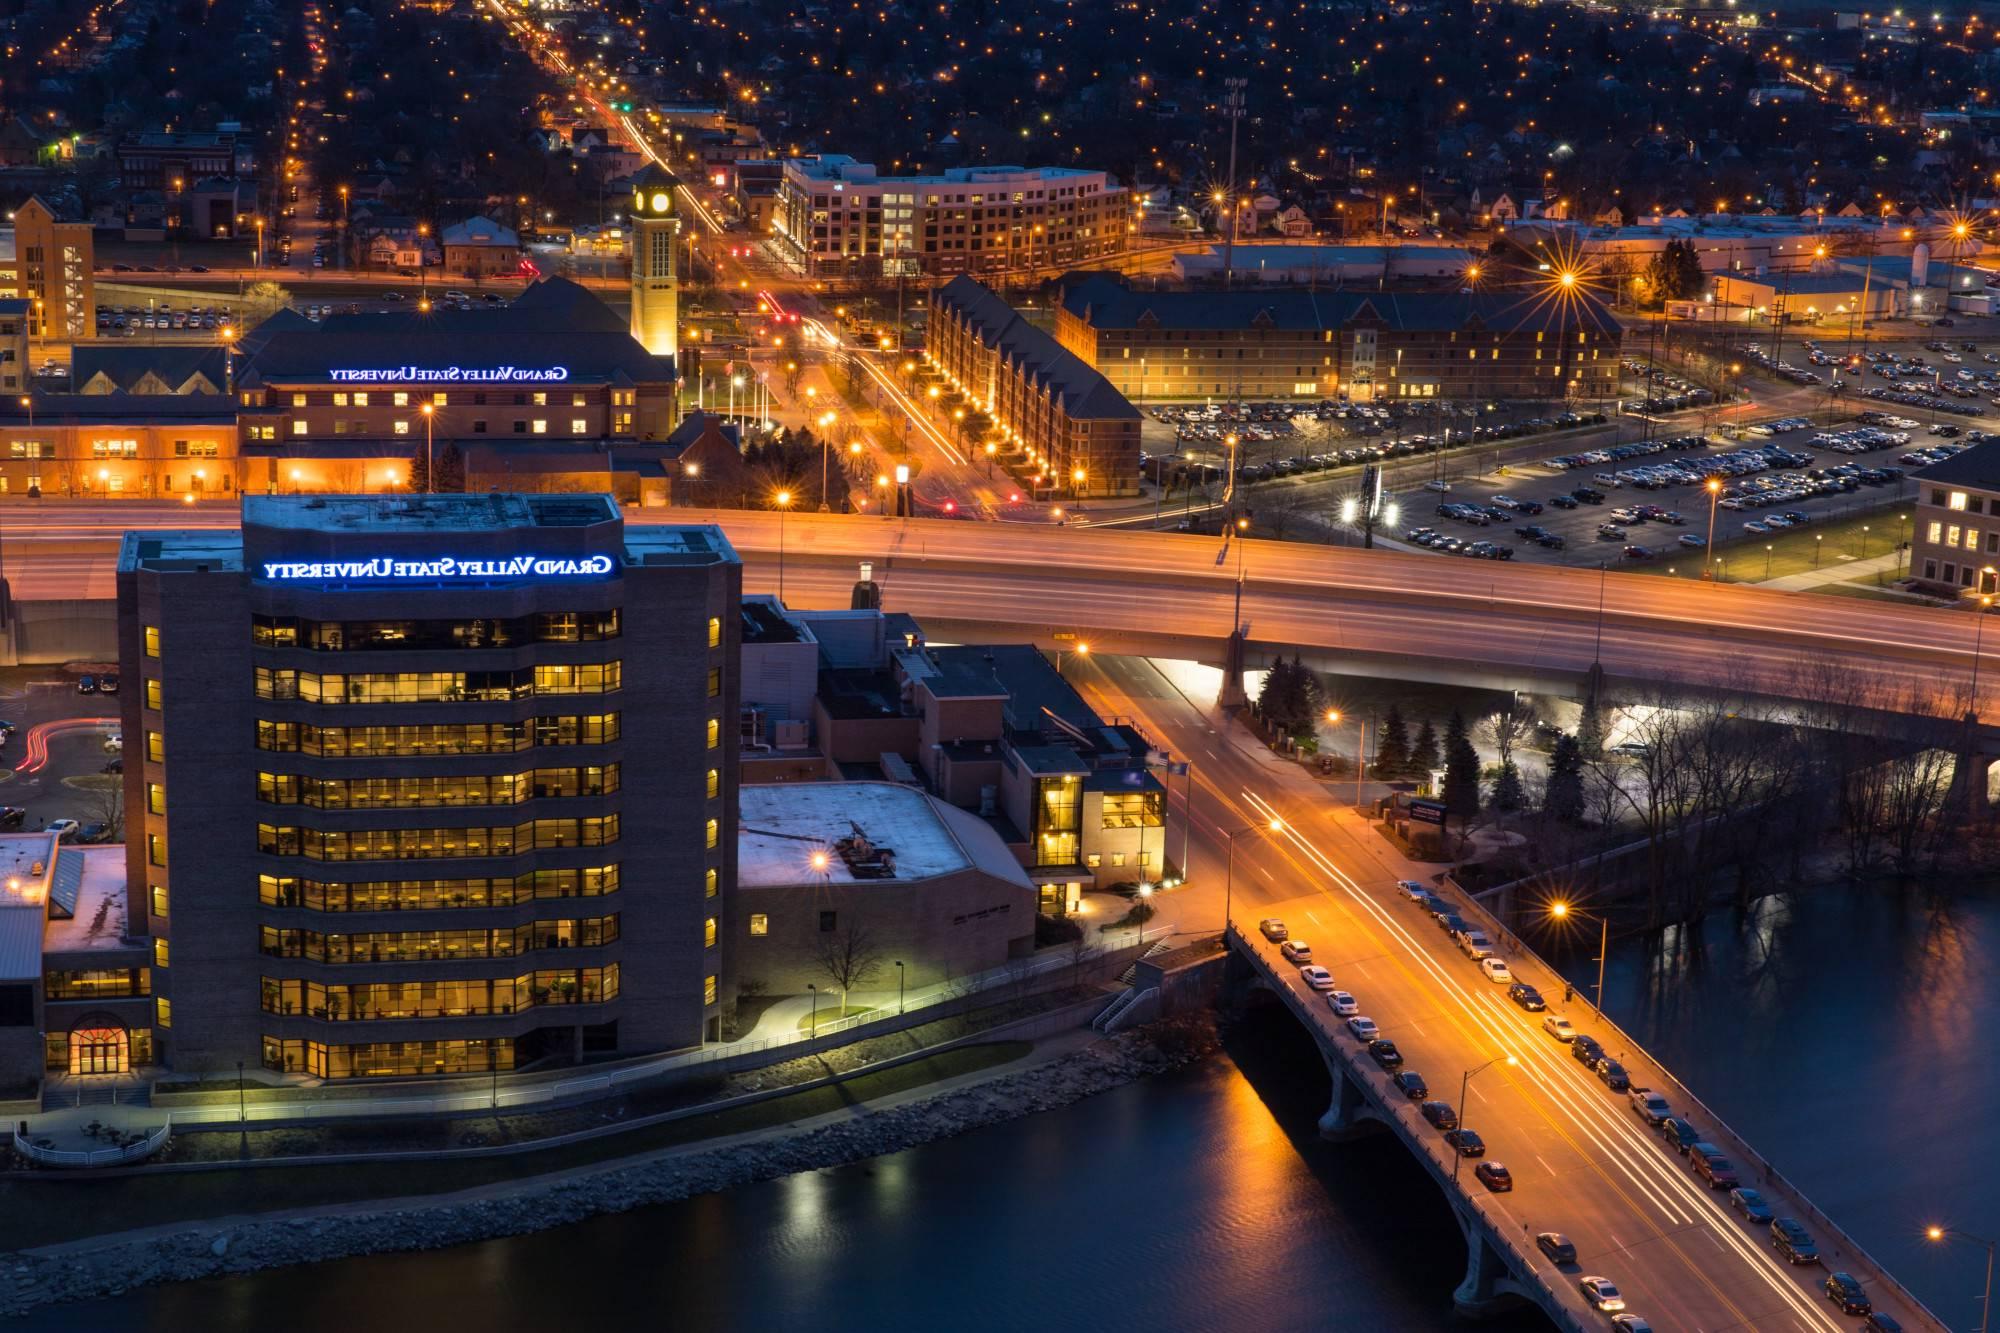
top-left (926, 276), bottom-right (1140, 496)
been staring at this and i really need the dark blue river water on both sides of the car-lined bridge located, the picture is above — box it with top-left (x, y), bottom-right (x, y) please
top-left (12, 876), bottom-right (2000, 1333)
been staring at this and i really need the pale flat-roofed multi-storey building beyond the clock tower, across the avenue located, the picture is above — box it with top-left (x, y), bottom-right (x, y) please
top-left (772, 154), bottom-right (1132, 278)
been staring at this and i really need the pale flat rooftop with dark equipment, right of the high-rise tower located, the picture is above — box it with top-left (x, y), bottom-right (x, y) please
top-left (736, 783), bottom-right (972, 889)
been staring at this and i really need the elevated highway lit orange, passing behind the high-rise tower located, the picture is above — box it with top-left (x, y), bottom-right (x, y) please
top-left (0, 502), bottom-right (1976, 697)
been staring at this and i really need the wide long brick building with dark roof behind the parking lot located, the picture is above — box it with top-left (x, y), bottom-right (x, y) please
top-left (1056, 272), bottom-right (1620, 402)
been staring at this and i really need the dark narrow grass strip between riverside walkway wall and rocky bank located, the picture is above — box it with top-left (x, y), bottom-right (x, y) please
top-left (0, 1041), bottom-right (1032, 1249)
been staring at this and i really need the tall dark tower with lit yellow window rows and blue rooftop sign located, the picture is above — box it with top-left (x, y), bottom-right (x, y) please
top-left (118, 494), bottom-right (742, 1079)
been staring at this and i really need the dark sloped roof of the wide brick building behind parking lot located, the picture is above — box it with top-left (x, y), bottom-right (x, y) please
top-left (1062, 274), bottom-right (1616, 332)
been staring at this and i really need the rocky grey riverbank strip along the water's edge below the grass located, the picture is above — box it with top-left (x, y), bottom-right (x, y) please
top-left (0, 1013), bottom-right (1216, 1315)
